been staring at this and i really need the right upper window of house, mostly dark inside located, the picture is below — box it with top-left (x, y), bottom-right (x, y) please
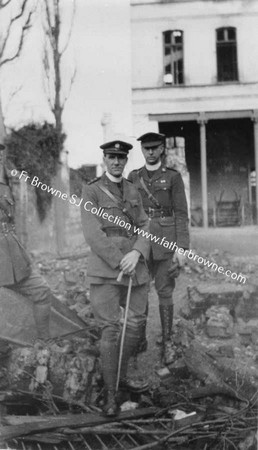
top-left (216, 27), bottom-right (238, 81)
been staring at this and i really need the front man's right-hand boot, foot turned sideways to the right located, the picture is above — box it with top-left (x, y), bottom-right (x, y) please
top-left (119, 324), bottom-right (148, 393)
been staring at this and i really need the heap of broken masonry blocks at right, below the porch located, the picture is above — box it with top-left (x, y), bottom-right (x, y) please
top-left (179, 251), bottom-right (258, 383)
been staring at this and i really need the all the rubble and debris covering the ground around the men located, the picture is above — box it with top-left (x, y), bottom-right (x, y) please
top-left (0, 252), bottom-right (258, 450)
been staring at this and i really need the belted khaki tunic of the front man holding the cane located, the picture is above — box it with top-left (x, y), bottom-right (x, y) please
top-left (81, 174), bottom-right (150, 285)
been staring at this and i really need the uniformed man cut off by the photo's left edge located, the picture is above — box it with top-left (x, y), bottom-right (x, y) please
top-left (0, 144), bottom-right (52, 339)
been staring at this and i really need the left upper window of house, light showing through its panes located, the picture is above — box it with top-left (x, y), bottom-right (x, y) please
top-left (163, 30), bottom-right (184, 84)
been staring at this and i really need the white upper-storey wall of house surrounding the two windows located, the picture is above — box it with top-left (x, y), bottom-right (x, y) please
top-left (131, 0), bottom-right (258, 89)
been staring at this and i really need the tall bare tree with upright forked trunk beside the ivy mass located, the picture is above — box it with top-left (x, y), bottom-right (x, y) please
top-left (42, 0), bottom-right (76, 253)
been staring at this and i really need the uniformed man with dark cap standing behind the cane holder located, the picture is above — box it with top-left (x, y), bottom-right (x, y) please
top-left (128, 133), bottom-right (189, 364)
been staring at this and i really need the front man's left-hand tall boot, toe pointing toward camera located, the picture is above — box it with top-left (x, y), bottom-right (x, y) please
top-left (100, 327), bottom-right (118, 417)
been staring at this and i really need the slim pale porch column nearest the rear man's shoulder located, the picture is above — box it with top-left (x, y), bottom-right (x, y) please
top-left (197, 113), bottom-right (209, 228)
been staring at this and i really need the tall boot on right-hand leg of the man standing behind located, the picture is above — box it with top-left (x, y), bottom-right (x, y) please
top-left (159, 305), bottom-right (175, 364)
